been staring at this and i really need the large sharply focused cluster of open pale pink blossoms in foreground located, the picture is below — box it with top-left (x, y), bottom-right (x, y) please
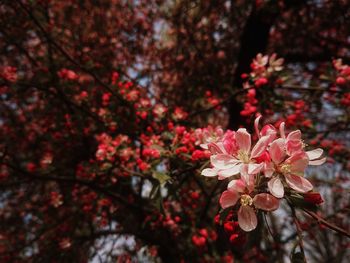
top-left (202, 116), bottom-right (326, 231)
